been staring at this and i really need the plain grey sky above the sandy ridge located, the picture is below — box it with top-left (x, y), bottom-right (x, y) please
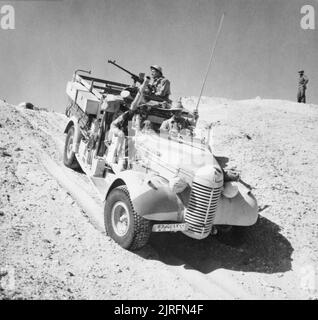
top-left (0, 0), bottom-right (318, 112)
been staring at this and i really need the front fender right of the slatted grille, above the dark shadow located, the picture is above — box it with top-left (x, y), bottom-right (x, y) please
top-left (214, 183), bottom-right (258, 226)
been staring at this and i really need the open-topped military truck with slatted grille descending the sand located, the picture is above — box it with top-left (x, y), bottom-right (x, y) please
top-left (64, 70), bottom-right (258, 250)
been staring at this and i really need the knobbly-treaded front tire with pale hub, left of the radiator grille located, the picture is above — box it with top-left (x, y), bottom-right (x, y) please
top-left (104, 186), bottom-right (151, 250)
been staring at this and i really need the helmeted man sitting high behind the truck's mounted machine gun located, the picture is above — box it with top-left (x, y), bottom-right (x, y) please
top-left (150, 65), bottom-right (171, 101)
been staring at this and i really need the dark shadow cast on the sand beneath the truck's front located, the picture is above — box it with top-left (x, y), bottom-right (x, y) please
top-left (138, 212), bottom-right (293, 274)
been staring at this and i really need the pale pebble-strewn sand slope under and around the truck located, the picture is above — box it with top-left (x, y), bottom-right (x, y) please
top-left (0, 98), bottom-right (318, 299)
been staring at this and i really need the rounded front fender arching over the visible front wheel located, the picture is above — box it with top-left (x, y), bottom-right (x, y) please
top-left (105, 170), bottom-right (184, 222)
